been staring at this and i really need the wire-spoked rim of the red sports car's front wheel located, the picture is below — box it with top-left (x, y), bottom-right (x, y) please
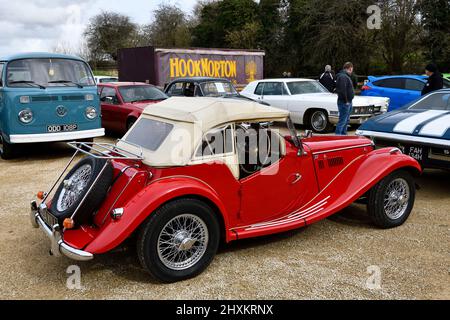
top-left (384, 178), bottom-right (410, 220)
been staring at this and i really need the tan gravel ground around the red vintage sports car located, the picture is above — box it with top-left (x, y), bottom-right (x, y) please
top-left (0, 138), bottom-right (450, 299)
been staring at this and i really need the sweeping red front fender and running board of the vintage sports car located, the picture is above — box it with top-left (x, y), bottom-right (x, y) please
top-left (234, 148), bottom-right (421, 239)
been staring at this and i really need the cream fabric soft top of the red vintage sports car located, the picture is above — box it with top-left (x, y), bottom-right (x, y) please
top-left (118, 97), bottom-right (289, 167)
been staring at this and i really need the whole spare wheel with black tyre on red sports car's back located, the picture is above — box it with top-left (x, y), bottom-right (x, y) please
top-left (50, 157), bottom-right (113, 225)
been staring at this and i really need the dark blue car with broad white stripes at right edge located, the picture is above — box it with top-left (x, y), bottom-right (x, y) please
top-left (356, 89), bottom-right (450, 170)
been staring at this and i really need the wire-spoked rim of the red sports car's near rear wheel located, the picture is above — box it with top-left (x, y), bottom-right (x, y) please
top-left (157, 214), bottom-right (209, 271)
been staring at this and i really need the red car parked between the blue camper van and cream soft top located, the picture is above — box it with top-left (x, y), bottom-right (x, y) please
top-left (98, 82), bottom-right (168, 134)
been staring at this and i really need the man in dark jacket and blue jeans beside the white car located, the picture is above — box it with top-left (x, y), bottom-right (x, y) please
top-left (336, 62), bottom-right (355, 136)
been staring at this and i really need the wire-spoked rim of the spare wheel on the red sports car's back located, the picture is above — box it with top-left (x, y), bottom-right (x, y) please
top-left (56, 164), bottom-right (92, 211)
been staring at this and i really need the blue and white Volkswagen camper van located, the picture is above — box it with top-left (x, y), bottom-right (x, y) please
top-left (0, 53), bottom-right (105, 159)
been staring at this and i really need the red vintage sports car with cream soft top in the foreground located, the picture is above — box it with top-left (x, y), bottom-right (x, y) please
top-left (31, 98), bottom-right (421, 282)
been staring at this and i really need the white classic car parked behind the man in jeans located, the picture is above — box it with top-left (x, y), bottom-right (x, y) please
top-left (241, 78), bottom-right (390, 133)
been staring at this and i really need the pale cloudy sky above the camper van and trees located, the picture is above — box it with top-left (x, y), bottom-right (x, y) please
top-left (0, 0), bottom-right (197, 57)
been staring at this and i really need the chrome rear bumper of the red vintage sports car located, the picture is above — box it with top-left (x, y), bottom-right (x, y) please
top-left (30, 201), bottom-right (94, 261)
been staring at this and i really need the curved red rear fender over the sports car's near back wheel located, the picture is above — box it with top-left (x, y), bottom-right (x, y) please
top-left (85, 177), bottom-right (229, 254)
